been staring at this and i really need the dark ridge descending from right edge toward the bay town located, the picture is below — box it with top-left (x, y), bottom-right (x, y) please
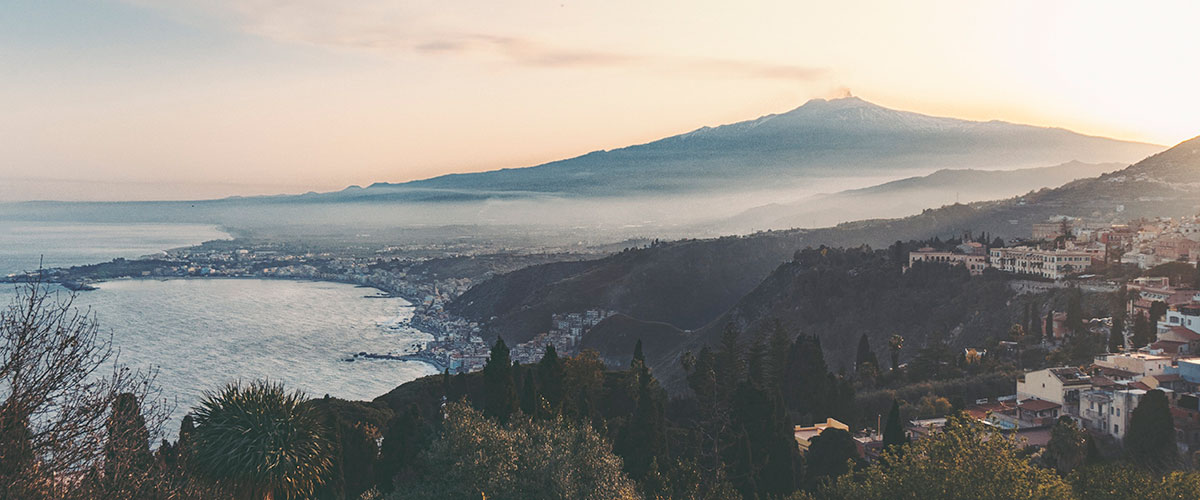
top-left (450, 138), bottom-right (1200, 390)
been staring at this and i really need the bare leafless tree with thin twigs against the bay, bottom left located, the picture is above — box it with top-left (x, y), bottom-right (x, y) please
top-left (0, 281), bottom-right (167, 498)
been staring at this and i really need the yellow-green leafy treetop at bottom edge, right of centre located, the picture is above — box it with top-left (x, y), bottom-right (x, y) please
top-left (818, 415), bottom-right (1072, 500)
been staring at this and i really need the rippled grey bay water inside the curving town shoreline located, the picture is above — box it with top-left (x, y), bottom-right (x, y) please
top-left (0, 279), bottom-right (437, 430)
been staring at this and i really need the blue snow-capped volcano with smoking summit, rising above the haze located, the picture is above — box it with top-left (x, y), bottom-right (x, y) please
top-left (337, 97), bottom-right (1162, 198)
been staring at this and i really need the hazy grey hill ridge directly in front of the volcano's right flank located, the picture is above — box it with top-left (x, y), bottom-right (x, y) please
top-left (719, 162), bottom-right (1124, 231)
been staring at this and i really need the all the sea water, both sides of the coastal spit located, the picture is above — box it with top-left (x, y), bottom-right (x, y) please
top-left (0, 222), bottom-right (437, 434)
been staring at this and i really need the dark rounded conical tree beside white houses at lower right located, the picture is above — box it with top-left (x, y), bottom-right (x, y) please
top-left (1124, 388), bottom-right (1178, 471)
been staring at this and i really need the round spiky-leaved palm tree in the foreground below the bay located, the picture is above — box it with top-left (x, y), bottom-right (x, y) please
top-left (188, 380), bottom-right (332, 500)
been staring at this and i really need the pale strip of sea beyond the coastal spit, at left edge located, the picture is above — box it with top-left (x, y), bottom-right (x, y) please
top-left (0, 221), bottom-right (229, 276)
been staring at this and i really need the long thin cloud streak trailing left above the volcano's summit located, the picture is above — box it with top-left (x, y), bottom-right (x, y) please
top-left (127, 0), bottom-right (827, 80)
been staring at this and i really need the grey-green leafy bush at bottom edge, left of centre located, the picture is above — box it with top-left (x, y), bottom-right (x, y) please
top-left (391, 403), bottom-right (641, 500)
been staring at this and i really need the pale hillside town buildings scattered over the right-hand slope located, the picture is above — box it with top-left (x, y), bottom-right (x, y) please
top-left (794, 212), bottom-right (1200, 460)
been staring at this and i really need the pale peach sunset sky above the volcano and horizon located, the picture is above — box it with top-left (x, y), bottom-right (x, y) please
top-left (0, 0), bottom-right (1200, 201)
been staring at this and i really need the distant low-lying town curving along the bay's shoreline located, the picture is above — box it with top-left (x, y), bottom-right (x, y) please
top-left (0, 241), bottom-right (616, 373)
